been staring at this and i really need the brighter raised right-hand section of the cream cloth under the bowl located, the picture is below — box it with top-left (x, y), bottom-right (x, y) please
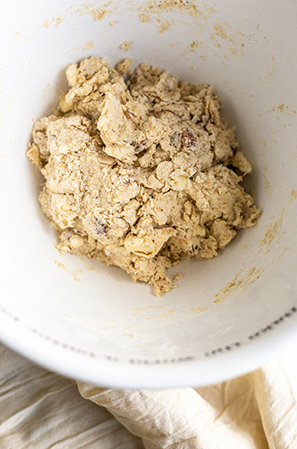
top-left (78, 349), bottom-right (297, 449)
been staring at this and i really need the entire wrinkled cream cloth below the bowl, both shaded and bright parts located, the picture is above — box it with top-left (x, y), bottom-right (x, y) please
top-left (0, 344), bottom-right (297, 449)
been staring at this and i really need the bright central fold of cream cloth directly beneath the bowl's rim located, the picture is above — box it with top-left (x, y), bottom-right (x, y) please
top-left (78, 382), bottom-right (221, 449)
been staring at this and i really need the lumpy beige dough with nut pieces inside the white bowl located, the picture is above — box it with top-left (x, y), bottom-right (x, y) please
top-left (27, 57), bottom-right (260, 295)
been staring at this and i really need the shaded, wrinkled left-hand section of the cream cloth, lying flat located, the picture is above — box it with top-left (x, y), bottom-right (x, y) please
top-left (0, 344), bottom-right (143, 449)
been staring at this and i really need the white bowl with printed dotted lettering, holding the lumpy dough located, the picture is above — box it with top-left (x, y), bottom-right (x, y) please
top-left (0, 0), bottom-right (297, 388)
